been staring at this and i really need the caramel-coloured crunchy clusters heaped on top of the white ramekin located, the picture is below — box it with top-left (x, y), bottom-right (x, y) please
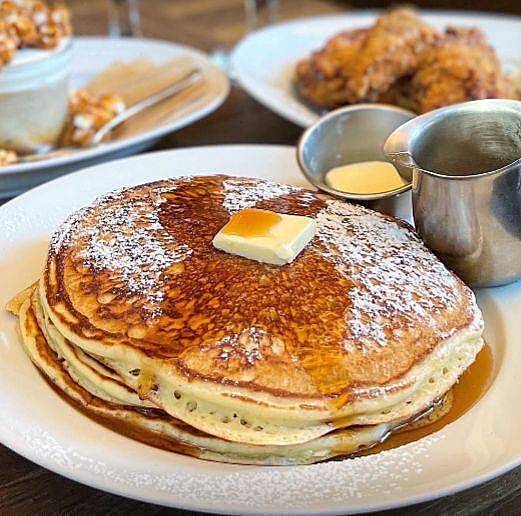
top-left (0, 0), bottom-right (72, 68)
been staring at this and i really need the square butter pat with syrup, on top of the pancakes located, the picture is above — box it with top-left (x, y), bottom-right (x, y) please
top-left (213, 208), bottom-right (316, 265)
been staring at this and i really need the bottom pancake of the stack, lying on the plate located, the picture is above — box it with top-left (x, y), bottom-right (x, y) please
top-left (17, 289), bottom-right (452, 465)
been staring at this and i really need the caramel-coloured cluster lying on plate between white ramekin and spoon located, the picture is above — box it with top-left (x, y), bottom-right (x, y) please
top-left (61, 89), bottom-right (125, 147)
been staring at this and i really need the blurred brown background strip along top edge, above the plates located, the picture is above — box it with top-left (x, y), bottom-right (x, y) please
top-left (66, 0), bottom-right (521, 51)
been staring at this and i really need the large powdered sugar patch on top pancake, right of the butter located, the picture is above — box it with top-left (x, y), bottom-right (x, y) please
top-left (317, 200), bottom-right (458, 347)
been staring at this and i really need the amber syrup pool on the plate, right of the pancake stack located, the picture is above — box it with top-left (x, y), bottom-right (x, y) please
top-left (358, 345), bottom-right (494, 455)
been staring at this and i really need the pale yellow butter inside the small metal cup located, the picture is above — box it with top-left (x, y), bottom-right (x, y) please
top-left (326, 161), bottom-right (407, 194)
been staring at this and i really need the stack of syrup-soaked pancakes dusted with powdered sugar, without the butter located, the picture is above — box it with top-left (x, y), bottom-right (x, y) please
top-left (9, 176), bottom-right (483, 464)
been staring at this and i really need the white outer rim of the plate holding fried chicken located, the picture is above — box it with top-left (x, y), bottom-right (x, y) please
top-left (230, 9), bottom-right (521, 128)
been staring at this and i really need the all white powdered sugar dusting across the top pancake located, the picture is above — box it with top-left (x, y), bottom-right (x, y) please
top-left (48, 176), bottom-right (479, 351)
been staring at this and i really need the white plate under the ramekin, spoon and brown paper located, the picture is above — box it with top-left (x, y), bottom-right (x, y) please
top-left (0, 37), bottom-right (229, 199)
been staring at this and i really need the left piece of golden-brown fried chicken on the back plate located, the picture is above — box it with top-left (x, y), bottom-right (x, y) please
top-left (296, 8), bottom-right (438, 108)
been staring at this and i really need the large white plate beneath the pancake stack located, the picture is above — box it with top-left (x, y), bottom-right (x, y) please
top-left (0, 145), bottom-right (521, 514)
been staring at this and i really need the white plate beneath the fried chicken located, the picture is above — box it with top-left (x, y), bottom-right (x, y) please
top-left (231, 11), bottom-right (521, 127)
